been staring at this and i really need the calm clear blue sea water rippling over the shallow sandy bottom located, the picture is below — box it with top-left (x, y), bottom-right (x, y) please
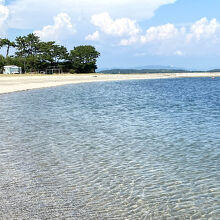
top-left (0, 78), bottom-right (220, 220)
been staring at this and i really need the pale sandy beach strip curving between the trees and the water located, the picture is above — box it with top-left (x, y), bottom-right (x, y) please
top-left (0, 73), bottom-right (220, 94)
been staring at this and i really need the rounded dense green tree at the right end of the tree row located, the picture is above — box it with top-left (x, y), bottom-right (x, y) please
top-left (69, 45), bottom-right (100, 73)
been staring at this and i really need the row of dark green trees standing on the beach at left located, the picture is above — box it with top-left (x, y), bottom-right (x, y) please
top-left (0, 33), bottom-right (100, 73)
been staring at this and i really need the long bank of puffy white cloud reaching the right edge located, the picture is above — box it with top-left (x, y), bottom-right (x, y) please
top-left (120, 18), bottom-right (220, 56)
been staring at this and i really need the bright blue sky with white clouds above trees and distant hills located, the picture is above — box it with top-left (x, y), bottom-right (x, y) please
top-left (0, 0), bottom-right (220, 70)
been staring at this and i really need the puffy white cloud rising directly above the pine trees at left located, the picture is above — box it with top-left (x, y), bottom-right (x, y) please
top-left (34, 13), bottom-right (76, 41)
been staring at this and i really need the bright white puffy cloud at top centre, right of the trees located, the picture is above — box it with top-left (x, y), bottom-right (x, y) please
top-left (91, 12), bottom-right (140, 36)
